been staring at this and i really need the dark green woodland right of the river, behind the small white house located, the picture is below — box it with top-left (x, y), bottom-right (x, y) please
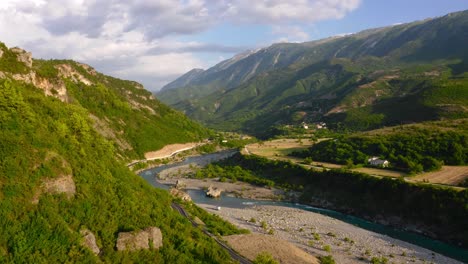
top-left (293, 125), bottom-right (468, 173)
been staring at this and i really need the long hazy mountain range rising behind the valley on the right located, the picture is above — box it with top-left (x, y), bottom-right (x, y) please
top-left (156, 11), bottom-right (468, 135)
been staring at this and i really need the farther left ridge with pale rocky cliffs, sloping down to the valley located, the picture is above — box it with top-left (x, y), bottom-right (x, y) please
top-left (0, 44), bottom-right (210, 160)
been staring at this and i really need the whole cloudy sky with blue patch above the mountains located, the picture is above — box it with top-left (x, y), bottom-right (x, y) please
top-left (0, 0), bottom-right (468, 91)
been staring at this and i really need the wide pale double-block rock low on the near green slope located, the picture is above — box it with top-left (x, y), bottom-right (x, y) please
top-left (116, 227), bottom-right (162, 251)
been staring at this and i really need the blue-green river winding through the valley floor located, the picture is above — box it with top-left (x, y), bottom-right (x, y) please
top-left (140, 151), bottom-right (468, 263)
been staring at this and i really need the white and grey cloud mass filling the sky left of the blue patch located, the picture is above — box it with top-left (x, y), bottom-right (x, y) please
top-left (0, 0), bottom-right (361, 89)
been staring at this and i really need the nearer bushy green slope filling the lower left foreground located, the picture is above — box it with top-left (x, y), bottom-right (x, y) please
top-left (0, 80), bottom-right (238, 263)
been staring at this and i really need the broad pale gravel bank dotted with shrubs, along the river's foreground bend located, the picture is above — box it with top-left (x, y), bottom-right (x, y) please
top-left (198, 204), bottom-right (461, 264)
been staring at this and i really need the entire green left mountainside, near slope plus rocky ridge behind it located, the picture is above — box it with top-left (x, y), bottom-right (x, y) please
top-left (0, 44), bottom-right (241, 263)
